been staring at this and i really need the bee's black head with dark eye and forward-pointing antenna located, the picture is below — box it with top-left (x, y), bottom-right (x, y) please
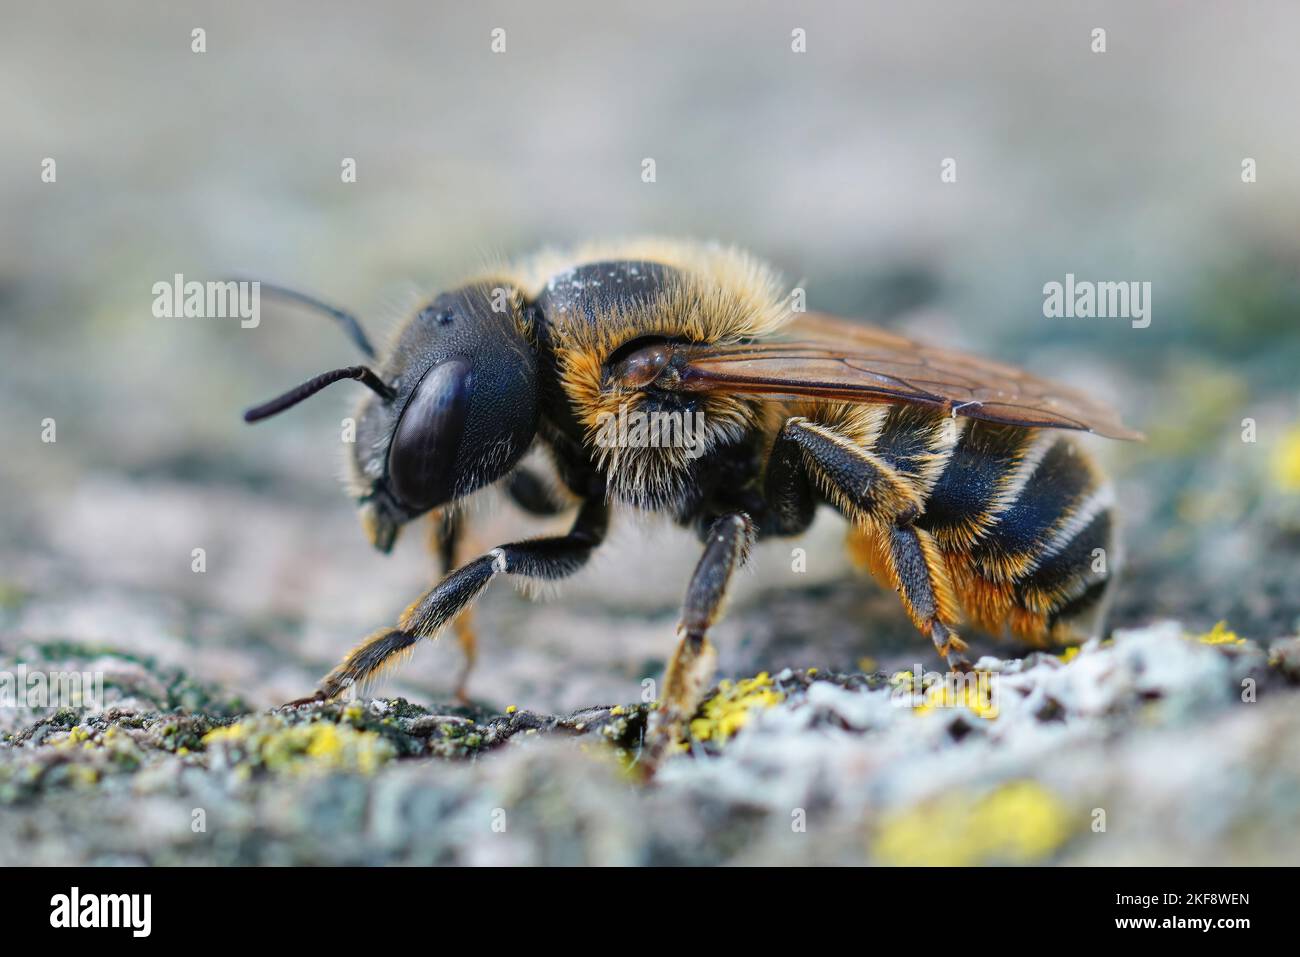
top-left (244, 281), bottom-right (538, 551)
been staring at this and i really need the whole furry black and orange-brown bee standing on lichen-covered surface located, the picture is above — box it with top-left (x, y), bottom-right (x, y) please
top-left (244, 241), bottom-right (1140, 765)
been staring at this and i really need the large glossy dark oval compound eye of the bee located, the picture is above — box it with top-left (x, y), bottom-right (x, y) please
top-left (389, 359), bottom-right (473, 512)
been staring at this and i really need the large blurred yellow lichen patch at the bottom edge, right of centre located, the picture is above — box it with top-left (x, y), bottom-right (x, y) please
top-left (872, 780), bottom-right (1073, 867)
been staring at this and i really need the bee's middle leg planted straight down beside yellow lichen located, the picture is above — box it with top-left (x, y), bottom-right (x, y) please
top-left (642, 512), bottom-right (754, 774)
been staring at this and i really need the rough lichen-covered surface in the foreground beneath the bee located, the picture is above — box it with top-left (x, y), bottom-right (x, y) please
top-left (0, 623), bottom-right (1300, 865)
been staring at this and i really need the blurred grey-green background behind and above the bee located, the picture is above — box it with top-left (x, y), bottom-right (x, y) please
top-left (0, 0), bottom-right (1300, 709)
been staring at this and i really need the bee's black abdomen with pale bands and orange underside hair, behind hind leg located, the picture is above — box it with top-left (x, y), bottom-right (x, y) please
top-left (917, 421), bottom-right (1114, 644)
